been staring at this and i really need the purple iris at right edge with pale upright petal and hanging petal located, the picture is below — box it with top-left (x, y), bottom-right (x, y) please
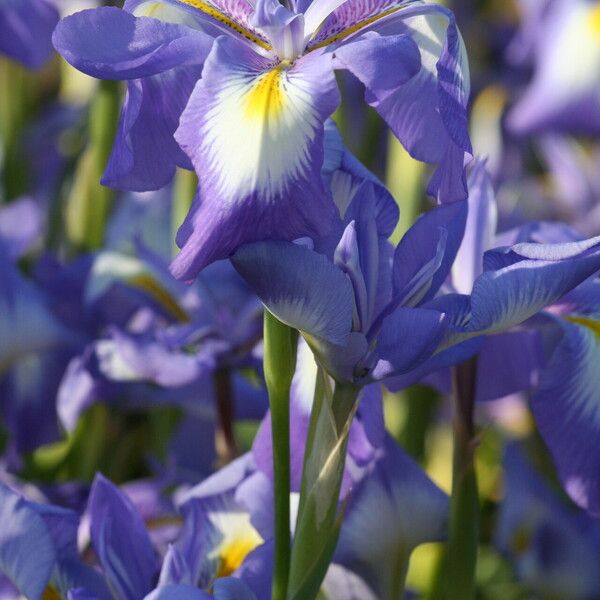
top-left (442, 163), bottom-right (600, 514)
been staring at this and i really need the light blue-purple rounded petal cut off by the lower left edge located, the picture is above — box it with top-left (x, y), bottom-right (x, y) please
top-left (0, 483), bottom-right (57, 600)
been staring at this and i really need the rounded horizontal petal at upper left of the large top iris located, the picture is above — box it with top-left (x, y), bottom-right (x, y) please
top-left (52, 7), bottom-right (213, 79)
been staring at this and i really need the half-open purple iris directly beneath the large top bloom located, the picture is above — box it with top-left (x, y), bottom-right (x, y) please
top-left (232, 176), bottom-right (467, 385)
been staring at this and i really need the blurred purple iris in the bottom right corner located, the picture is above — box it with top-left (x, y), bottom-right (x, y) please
top-left (496, 445), bottom-right (600, 600)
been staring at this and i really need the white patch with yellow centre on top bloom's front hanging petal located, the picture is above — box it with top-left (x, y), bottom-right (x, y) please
top-left (199, 66), bottom-right (319, 203)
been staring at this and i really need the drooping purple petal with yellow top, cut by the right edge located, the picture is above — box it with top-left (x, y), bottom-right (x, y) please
top-left (531, 318), bottom-right (600, 516)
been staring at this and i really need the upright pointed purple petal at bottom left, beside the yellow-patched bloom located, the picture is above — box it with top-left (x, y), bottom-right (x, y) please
top-left (88, 475), bottom-right (157, 600)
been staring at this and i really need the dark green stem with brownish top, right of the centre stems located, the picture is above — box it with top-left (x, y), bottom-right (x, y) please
top-left (446, 359), bottom-right (479, 600)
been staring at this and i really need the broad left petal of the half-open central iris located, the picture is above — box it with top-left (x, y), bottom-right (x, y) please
top-left (231, 242), bottom-right (353, 345)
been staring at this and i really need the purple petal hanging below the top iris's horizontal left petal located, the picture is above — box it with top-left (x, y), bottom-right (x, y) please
top-left (102, 67), bottom-right (200, 191)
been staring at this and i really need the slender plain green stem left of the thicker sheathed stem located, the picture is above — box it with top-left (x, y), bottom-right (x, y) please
top-left (264, 310), bottom-right (298, 600)
